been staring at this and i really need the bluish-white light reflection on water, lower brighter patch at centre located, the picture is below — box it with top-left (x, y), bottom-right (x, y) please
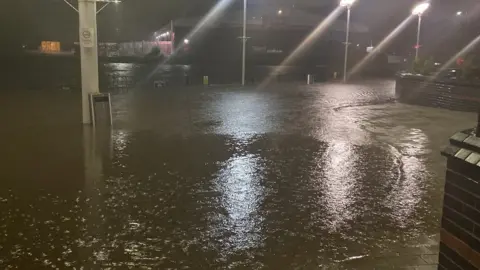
top-left (216, 154), bottom-right (264, 249)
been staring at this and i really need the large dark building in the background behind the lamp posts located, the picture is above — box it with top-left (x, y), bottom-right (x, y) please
top-left (158, 8), bottom-right (370, 66)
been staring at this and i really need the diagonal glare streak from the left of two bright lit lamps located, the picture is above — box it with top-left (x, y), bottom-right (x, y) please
top-left (259, 6), bottom-right (346, 88)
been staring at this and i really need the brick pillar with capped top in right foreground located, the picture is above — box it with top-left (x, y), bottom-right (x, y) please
top-left (438, 130), bottom-right (480, 270)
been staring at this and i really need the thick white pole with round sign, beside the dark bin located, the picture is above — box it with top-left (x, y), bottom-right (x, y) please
top-left (78, 0), bottom-right (100, 124)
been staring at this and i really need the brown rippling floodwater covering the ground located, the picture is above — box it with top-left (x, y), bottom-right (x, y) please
top-left (0, 80), bottom-right (476, 269)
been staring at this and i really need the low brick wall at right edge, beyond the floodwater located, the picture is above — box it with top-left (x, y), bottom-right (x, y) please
top-left (395, 76), bottom-right (480, 112)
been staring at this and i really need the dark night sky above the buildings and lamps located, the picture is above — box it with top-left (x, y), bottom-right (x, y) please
top-left (0, 0), bottom-right (480, 56)
